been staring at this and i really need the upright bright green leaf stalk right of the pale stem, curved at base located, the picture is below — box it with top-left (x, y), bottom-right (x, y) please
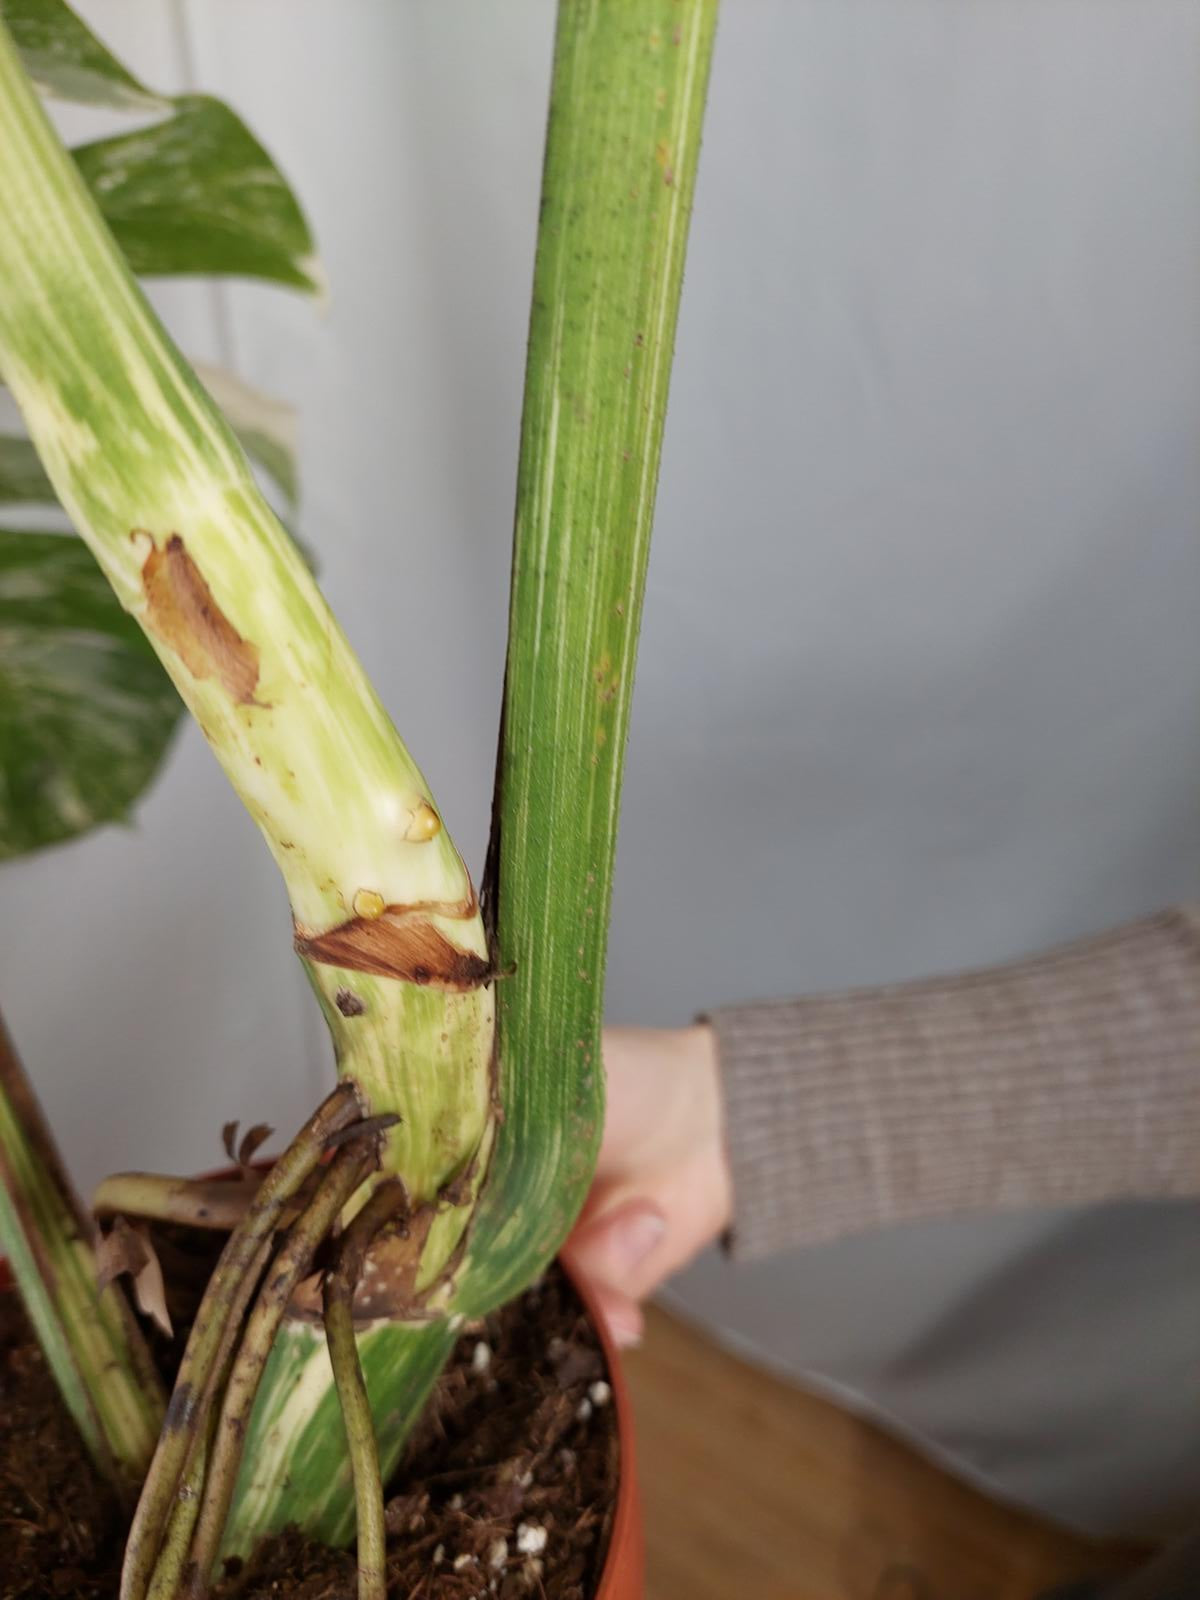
top-left (456, 0), bottom-right (717, 1315)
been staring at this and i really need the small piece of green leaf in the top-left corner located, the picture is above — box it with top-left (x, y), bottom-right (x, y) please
top-left (0, 0), bottom-right (168, 110)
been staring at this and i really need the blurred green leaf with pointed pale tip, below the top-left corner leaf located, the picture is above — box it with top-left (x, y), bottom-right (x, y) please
top-left (72, 94), bottom-right (322, 290)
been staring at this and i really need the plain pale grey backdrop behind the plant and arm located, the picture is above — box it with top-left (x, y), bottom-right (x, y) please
top-left (0, 0), bottom-right (1200, 1542)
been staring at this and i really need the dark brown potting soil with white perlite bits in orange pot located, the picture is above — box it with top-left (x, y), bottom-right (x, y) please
top-left (0, 1269), bottom-right (618, 1600)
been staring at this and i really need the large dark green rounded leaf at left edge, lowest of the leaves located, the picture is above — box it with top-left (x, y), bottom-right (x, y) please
top-left (0, 530), bottom-right (182, 859)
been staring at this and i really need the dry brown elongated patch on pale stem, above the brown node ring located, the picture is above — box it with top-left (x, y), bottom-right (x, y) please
top-left (131, 528), bottom-right (262, 706)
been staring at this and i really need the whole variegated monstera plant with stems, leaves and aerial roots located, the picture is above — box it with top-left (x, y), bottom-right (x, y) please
top-left (0, 0), bottom-right (715, 1600)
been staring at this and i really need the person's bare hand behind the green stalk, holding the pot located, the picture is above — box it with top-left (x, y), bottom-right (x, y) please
top-left (563, 1024), bottom-right (733, 1346)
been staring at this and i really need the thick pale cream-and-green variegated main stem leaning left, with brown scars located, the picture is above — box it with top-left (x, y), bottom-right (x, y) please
top-left (0, 26), bottom-right (498, 1552)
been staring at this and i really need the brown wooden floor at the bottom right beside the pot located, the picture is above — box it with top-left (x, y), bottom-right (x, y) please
top-left (626, 1309), bottom-right (1130, 1600)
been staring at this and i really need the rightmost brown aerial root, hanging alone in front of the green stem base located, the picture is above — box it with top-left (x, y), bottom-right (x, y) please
top-left (323, 1182), bottom-right (408, 1600)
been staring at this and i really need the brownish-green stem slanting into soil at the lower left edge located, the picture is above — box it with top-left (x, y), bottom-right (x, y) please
top-left (0, 1019), bottom-right (163, 1499)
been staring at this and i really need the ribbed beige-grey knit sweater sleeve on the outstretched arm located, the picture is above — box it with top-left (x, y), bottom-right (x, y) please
top-left (710, 907), bottom-right (1200, 1258)
